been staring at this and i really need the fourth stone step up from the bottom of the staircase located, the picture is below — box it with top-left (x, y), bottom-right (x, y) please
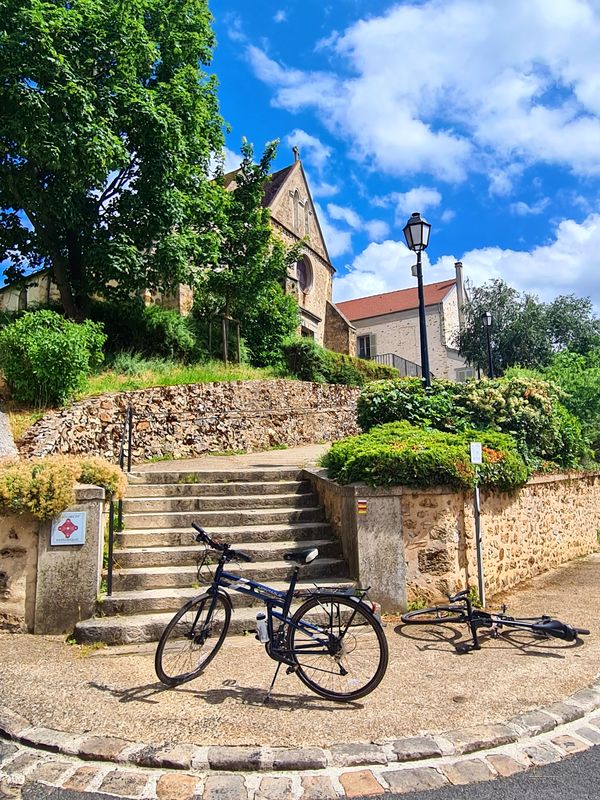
top-left (114, 538), bottom-right (341, 572)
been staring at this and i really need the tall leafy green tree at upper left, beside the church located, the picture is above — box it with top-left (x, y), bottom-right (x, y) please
top-left (0, 0), bottom-right (224, 318)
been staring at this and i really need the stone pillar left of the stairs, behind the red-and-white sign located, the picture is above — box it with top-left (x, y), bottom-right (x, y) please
top-left (33, 485), bottom-right (105, 634)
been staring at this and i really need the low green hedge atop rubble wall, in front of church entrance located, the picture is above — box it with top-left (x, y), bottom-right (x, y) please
top-left (283, 336), bottom-right (398, 386)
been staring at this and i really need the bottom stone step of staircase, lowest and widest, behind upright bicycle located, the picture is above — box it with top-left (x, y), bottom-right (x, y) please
top-left (74, 602), bottom-right (354, 658)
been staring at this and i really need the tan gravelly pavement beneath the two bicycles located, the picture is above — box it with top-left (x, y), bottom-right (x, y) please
top-left (0, 554), bottom-right (600, 746)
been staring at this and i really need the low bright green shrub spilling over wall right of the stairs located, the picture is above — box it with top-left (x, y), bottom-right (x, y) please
top-left (322, 422), bottom-right (530, 490)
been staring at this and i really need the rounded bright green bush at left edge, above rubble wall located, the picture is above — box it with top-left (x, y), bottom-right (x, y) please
top-left (0, 311), bottom-right (106, 405)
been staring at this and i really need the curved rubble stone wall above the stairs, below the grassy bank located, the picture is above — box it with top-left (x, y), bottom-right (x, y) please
top-left (19, 380), bottom-right (359, 463)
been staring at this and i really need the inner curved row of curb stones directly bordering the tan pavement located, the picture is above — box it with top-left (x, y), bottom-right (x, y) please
top-left (0, 678), bottom-right (600, 776)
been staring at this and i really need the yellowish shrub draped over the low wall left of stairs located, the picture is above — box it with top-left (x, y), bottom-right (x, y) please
top-left (0, 456), bottom-right (126, 519)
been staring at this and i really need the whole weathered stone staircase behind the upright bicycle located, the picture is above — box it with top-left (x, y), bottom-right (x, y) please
top-left (75, 468), bottom-right (353, 645)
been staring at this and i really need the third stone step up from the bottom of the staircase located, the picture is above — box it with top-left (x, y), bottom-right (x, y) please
top-left (108, 558), bottom-right (346, 592)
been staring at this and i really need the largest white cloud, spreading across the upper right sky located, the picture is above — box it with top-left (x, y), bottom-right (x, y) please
top-left (247, 0), bottom-right (600, 183)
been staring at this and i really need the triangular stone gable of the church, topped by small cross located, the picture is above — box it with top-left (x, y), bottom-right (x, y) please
top-left (265, 161), bottom-right (331, 264)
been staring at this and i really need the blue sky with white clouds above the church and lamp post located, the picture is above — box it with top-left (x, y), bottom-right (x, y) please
top-left (210, 0), bottom-right (600, 309)
